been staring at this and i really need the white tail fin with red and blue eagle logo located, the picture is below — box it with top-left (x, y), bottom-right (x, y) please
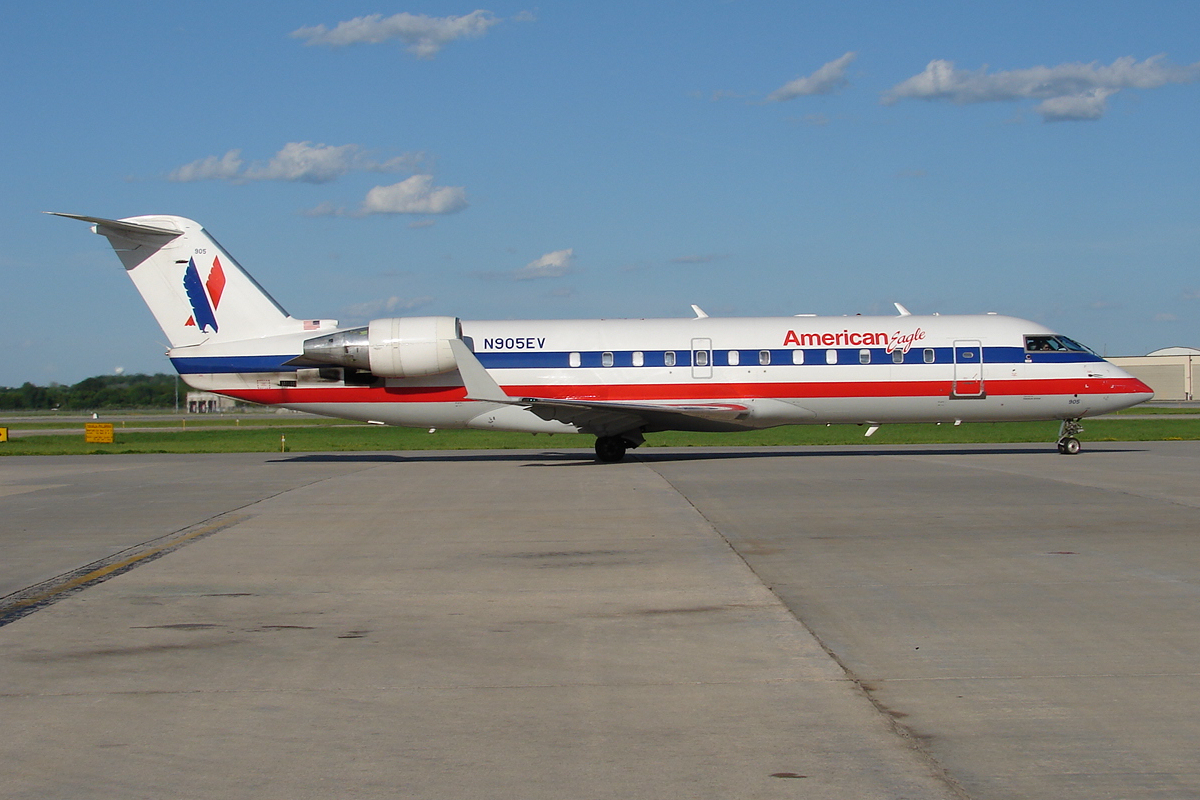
top-left (49, 211), bottom-right (305, 348)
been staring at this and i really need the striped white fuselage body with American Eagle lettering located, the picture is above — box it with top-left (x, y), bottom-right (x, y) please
top-left (172, 314), bottom-right (1151, 433)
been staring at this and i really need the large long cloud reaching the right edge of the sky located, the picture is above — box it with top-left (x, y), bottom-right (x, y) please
top-left (882, 55), bottom-right (1200, 122)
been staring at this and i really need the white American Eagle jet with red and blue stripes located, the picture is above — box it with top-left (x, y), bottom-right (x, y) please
top-left (48, 212), bottom-right (1153, 462)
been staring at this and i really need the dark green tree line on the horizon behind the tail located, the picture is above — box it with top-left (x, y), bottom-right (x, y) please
top-left (0, 373), bottom-right (180, 411)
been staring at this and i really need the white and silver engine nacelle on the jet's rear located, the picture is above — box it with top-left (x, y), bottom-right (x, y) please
top-left (304, 317), bottom-right (462, 378)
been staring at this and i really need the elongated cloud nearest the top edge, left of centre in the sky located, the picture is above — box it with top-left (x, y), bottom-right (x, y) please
top-left (292, 10), bottom-right (504, 59)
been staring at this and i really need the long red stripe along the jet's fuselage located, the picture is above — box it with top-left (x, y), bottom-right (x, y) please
top-left (216, 378), bottom-right (1152, 405)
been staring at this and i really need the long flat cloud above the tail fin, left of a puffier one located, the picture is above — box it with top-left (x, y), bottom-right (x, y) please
top-left (167, 142), bottom-right (425, 184)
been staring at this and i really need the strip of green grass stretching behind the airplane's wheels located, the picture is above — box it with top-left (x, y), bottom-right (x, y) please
top-left (0, 416), bottom-right (1200, 456)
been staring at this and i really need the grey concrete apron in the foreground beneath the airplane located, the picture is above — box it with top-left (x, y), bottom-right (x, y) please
top-left (0, 441), bottom-right (1200, 800)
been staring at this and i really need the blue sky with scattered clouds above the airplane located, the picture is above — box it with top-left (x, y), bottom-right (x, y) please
top-left (0, 0), bottom-right (1200, 386)
